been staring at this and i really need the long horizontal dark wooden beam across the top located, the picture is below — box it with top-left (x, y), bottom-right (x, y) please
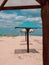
top-left (0, 5), bottom-right (41, 10)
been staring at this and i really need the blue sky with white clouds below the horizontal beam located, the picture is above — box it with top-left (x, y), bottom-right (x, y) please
top-left (0, 9), bottom-right (42, 28)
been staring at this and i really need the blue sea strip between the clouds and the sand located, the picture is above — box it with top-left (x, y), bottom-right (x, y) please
top-left (0, 28), bottom-right (42, 36)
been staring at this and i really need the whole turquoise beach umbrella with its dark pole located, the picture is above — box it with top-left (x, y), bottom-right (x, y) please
top-left (15, 21), bottom-right (41, 53)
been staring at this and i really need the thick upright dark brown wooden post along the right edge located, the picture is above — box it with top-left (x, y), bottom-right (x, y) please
top-left (41, 3), bottom-right (49, 65)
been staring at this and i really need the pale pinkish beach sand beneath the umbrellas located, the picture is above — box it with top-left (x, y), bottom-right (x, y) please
top-left (0, 36), bottom-right (43, 65)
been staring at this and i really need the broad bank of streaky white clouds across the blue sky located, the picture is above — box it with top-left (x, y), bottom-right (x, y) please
top-left (0, 9), bottom-right (41, 28)
